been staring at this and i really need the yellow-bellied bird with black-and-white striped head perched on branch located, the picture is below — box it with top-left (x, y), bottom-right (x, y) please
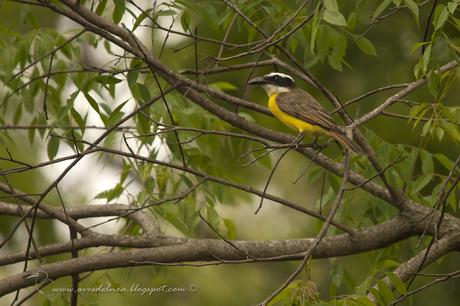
top-left (248, 72), bottom-right (361, 154)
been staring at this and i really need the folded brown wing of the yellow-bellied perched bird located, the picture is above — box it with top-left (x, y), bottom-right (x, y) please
top-left (276, 89), bottom-right (339, 131)
